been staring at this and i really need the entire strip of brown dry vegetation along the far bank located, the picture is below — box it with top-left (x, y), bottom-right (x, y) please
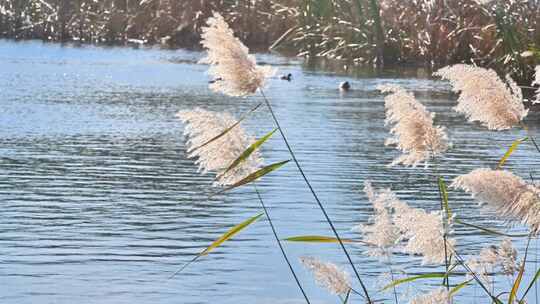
top-left (0, 0), bottom-right (540, 85)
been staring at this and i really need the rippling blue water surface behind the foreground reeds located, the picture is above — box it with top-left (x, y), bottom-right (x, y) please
top-left (0, 41), bottom-right (540, 304)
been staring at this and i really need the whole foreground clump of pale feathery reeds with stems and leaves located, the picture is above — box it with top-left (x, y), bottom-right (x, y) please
top-left (171, 13), bottom-right (540, 304)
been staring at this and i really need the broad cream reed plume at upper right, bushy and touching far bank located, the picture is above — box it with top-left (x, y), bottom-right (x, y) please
top-left (434, 64), bottom-right (528, 130)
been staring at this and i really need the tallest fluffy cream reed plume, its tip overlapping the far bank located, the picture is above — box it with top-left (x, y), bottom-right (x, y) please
top-left (201, 13), bottom-right (275, 96)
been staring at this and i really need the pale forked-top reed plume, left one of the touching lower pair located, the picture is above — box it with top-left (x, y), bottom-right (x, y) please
top-left (353, 181), bottom-right (400, 256)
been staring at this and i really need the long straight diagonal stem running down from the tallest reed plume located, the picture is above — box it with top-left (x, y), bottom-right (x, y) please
top-left (260, 89), bottom-right (372, 303)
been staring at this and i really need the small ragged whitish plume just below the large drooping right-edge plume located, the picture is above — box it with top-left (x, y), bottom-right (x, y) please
top-left (467, 239), bottom-right (519, 285)
